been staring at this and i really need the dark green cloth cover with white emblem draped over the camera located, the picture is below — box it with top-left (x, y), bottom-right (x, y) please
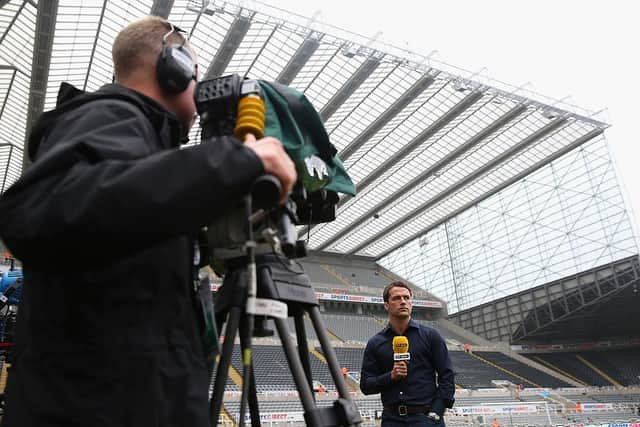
top-left (259, 80), bottom-right (356, 196)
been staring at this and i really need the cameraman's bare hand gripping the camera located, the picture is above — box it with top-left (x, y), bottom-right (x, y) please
top-left (244, 134), bottom-right (298, 203)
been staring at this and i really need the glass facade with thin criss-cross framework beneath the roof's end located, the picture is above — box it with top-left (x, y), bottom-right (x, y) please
top-left (379, 136), bottom-right (638, 313)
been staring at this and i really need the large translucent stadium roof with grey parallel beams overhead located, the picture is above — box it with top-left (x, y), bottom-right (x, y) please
top-left (0, 0), bottom-right (607, 258)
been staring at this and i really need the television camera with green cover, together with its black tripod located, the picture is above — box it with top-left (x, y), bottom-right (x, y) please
top-left (195, 75), bottom-right (361, 427)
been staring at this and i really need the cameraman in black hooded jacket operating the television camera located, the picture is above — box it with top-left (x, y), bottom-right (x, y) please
top-left (0, 17), bottom-right (296, 427)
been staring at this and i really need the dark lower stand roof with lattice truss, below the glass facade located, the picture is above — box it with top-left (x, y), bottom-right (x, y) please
top-left (450, 255), bottom-right (640, 344)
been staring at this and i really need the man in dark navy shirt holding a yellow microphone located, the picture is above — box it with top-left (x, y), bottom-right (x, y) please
top-left (360, 282), bottom-right (455, 427)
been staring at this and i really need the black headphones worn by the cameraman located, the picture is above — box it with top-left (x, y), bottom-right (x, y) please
top-left (156, 22), bottom-right (198, 96)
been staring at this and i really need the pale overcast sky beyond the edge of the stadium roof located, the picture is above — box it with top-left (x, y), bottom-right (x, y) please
top-left (256, 0), bottom-right (640, 234)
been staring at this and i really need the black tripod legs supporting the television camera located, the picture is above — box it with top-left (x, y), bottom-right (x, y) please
top-left (211, 254), bottom-right (361, 427)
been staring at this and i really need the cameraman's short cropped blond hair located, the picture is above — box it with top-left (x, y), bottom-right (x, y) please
top-left (111, 16), bottom-right (195, 82)
